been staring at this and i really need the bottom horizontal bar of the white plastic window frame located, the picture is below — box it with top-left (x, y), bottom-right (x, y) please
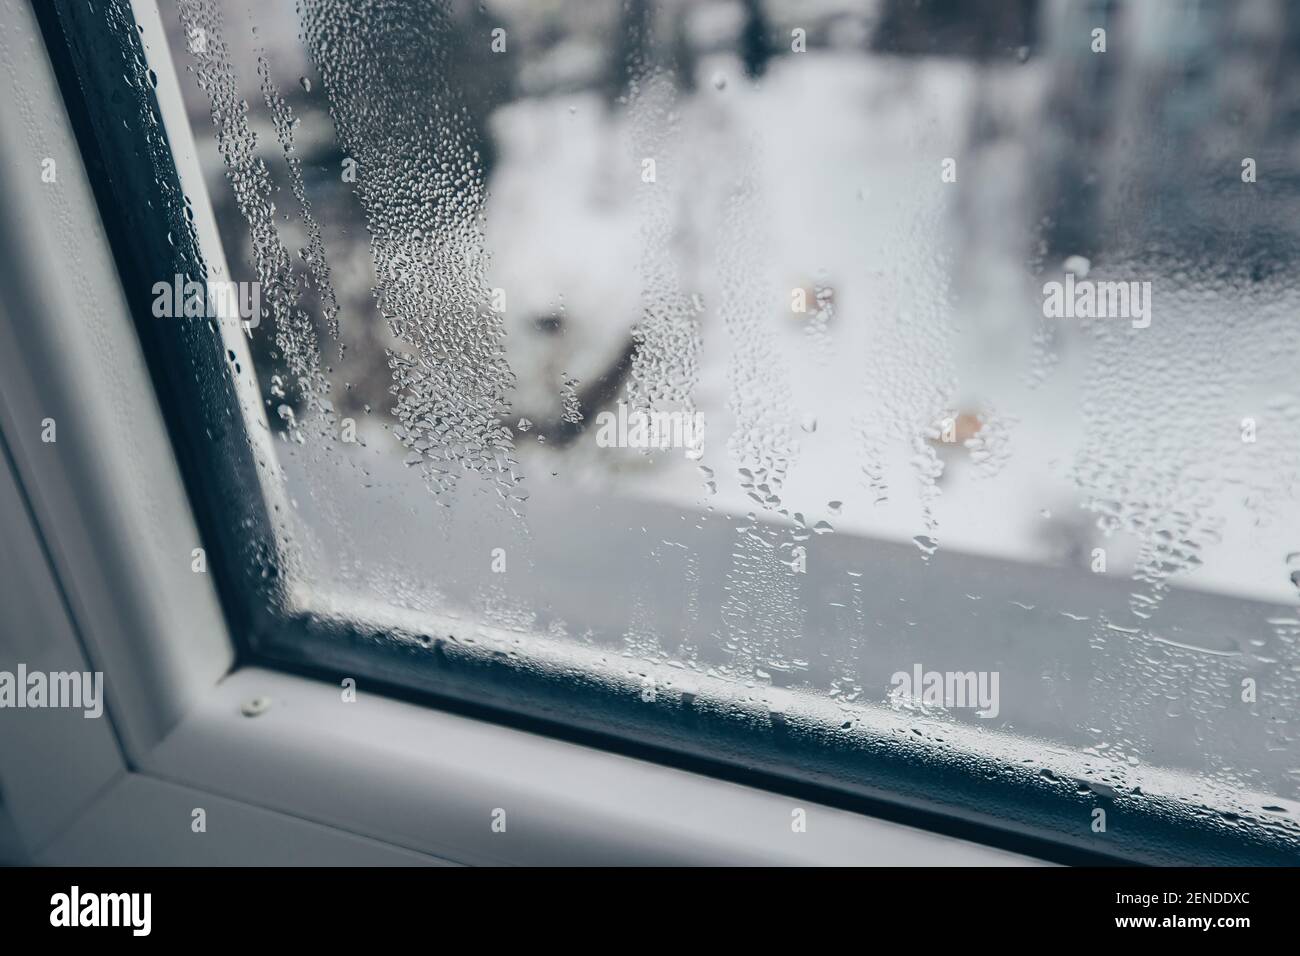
top-left (131, 667), bottom-right (1037, 866)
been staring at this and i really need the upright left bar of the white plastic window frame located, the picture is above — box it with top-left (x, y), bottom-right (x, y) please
top-left (0, 0), bottom-right (234, 757)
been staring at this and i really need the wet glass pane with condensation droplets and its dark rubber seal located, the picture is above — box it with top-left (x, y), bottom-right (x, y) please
top-left (35, 0), bottom-right (1300, 860)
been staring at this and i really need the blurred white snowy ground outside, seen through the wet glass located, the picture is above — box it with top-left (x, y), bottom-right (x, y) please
top-left (486, 46), bottom-right (1296, 602)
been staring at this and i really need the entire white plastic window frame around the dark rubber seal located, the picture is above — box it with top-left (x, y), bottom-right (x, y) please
top-left (0, 0), bottom-right (1037, 865)
